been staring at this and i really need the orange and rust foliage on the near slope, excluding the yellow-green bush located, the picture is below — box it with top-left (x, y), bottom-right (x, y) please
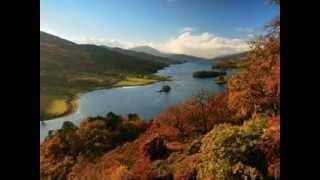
top-left (40, 15), bottom-right (280, 180)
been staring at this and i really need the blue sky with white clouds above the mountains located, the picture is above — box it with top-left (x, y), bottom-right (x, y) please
top-left (40, 0), bottom-right (279, 58)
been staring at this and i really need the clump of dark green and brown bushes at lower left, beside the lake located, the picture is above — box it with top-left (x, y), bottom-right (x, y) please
top-left (40, 112), bottom-right (145, 179)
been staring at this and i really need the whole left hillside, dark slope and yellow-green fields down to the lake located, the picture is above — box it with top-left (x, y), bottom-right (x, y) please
top-left (40, 31), bottom-right (177, 120)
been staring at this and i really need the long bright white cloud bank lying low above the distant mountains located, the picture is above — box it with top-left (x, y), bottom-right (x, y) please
top-left (75, 29), bottom-right (249, 58)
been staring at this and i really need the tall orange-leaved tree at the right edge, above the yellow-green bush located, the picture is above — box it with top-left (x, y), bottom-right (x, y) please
top-left (227, 38), bottom-right (280, 119)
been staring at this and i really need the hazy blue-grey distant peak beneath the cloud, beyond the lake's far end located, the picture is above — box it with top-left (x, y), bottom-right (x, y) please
top-left (129, 46), bottom-right (207, 61)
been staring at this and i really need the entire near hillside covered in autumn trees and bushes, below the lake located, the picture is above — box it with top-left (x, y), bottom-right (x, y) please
top-left (40, 22), bottom-right (280, 180)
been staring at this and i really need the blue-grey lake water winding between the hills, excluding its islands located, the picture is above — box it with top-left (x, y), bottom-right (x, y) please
top-left (40, 61), bottom-right (234, 141)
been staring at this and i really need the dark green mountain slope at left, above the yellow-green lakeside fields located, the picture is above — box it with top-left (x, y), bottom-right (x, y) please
top-left (40, 31), bottom-right (173, 76)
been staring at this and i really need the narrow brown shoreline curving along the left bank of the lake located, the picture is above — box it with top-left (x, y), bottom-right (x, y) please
top-left (40, 77), bottom-right (172, 123)
